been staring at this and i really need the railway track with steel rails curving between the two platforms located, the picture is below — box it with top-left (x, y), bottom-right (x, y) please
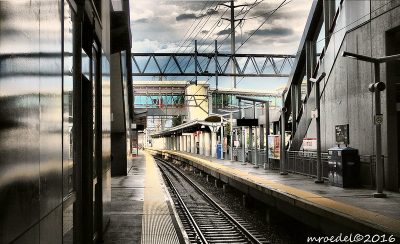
top-left (156, 158), bottom-right (269, 243)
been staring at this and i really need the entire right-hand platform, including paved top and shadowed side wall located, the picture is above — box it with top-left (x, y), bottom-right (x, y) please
top-left (147, 149), bottom-right (400, 238)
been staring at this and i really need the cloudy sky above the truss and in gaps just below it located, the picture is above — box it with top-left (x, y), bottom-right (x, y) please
top-left (131, 0), bottom-right (312, 89)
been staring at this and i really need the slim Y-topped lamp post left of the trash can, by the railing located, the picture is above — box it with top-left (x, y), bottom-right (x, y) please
top-left (310, 72), bottom-right (326, 184)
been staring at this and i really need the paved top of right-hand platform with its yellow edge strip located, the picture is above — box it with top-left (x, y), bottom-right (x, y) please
top-left (149, 150), bottom-right (400, 237)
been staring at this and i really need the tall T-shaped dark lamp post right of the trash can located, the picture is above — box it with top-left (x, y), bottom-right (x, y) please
top-left (342, 51), bottom-right (400, 198)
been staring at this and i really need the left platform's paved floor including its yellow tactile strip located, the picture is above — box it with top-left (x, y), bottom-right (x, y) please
top-left (104, 152), bottom-right (184, 244)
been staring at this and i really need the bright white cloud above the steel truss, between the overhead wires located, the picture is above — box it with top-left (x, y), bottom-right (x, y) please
top-left (131, 0), bottom-right (312, 87)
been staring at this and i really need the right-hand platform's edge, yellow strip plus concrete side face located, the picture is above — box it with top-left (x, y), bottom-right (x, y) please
top-left (149, 150), bottom-right (400, 237)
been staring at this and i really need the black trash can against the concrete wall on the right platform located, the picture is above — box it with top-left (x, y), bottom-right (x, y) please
top-left (328, 147), bottom-right (360, 188)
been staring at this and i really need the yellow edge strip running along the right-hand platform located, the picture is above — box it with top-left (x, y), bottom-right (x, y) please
top-left (148, 150), bottom-right (400, 237)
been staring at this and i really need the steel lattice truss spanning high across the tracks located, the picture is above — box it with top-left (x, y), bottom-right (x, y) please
top-left (131, 52), bottom-right (295, 77)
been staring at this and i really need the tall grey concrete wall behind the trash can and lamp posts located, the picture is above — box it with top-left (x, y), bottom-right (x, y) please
top-left (306, 0), bottom-right (400, 191)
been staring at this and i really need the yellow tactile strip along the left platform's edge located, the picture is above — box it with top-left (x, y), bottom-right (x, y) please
top-left (141, 152), bottom-right (179, 244)
